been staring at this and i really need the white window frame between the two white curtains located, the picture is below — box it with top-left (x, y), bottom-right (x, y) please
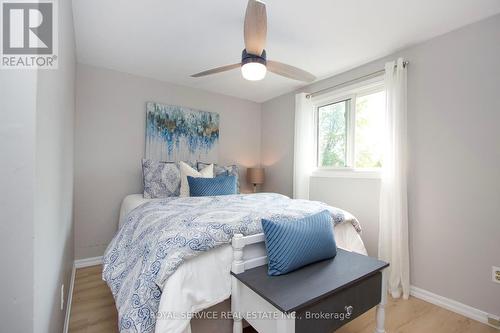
top-left (312, 76), bottom-right (385, 178)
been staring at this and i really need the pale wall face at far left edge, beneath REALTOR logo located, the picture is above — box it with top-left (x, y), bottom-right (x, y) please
top-left (0, 70), bottom-right (37, 333)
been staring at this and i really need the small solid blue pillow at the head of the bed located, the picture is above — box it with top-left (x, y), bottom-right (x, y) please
top-left (188, 176), bottom-right (238, 197)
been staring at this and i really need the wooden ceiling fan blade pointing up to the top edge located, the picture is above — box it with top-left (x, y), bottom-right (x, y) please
top-left (244, 0), bottom-right (267, 56)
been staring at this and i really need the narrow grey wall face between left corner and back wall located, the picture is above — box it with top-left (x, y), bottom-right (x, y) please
top-left (34, 1), bottom-right (75, 332)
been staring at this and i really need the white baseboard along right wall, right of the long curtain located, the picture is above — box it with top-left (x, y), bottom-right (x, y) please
top-left (410, 286), bottom-right (496, 328)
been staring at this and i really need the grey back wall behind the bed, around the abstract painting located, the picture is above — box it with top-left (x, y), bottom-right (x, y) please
top-left (75, 64), bottom-right (261, 259)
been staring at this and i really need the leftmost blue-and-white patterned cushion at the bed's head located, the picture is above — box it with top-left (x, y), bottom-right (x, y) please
top-left (142, 159), bottom-right (181, 199)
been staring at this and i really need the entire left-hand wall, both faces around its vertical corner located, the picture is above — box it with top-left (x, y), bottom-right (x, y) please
top-left (0, 1), bottom-right (75, 333)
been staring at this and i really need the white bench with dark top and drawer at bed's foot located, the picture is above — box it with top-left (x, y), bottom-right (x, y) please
top-left (231, 249), bottom-right (389, 333)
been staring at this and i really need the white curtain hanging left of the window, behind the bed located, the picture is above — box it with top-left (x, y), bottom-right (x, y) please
top-left (293, 93), bottom-right (314, 199)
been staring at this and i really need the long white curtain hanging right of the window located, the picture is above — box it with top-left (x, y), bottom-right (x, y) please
top-left (378, 58), bottom-right (410, 299)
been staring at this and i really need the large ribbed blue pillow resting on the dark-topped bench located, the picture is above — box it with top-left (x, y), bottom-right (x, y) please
top-left (262, 210), bottom-right (337, 275)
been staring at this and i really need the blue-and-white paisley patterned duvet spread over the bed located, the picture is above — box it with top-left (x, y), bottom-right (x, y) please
top-left (103, 193), bottom-right (361, 332)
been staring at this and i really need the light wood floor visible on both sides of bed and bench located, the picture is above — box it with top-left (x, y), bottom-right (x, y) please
top-left (69, 266), bottom-right (500, 333)
